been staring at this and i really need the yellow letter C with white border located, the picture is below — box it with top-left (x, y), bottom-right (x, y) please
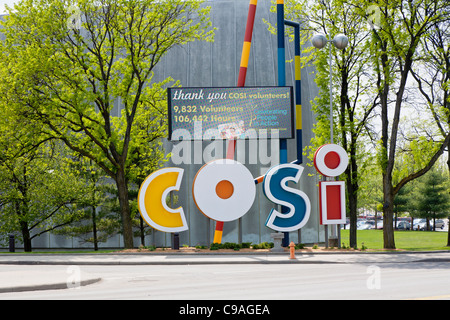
top-left (138, 168), bottom-right (188, 232)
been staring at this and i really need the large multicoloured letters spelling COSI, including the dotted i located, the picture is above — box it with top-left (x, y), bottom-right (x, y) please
top-left (138, 144), bottom-right (348, 232)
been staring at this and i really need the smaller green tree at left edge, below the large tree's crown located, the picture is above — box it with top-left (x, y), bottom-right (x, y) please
top-left (0, 76), bottom-right (86, 252)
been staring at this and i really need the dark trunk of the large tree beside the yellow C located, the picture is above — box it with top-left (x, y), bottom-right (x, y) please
top-left (116, 168), bottom-right (134, 249)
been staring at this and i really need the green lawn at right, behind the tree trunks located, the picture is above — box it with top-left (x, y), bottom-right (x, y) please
top-left (341, 230), bottom-right (450, 251)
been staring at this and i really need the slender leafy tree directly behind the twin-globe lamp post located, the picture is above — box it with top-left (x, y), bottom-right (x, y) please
top-left (309, 0), bottom-right (378, 247)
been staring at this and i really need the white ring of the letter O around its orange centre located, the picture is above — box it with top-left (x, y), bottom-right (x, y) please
top-left (192, 159), bottom-right (256, 222)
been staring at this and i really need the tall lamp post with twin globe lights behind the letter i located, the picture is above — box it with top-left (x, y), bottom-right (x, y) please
top-left (311, 33), bottom-right (348, 247)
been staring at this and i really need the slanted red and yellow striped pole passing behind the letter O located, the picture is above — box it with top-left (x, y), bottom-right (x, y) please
top-left (213, 0), bottom-right (258, 243)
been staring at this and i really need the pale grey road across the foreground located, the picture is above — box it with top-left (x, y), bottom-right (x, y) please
top-left (0, 261), bottom-right (450, 300)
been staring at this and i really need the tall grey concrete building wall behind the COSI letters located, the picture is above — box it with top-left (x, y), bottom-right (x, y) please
top-left (0, 0), bottom-right (324, 248)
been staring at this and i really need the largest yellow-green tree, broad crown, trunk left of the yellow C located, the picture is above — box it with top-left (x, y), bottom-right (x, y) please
top-left (0, 0), bottom-right (213, 248)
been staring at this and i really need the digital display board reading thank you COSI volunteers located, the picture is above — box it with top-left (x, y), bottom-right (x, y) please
top-left (167, 87), bottom-right (294, 140)
